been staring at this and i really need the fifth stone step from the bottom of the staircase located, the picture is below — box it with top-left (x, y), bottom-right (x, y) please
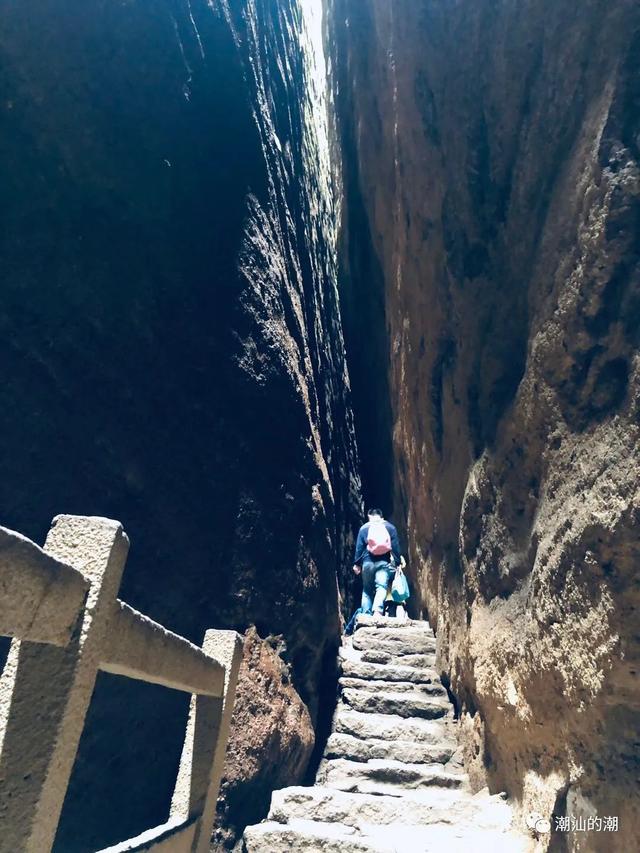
top-left (334, 705), bottom-right (457, 746)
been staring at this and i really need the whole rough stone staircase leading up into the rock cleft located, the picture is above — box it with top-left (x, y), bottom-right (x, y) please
top-left (244, 617), bottom-right (533, 853)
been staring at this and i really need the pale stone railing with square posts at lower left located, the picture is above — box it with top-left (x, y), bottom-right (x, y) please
top-left (0, 515), bottom-right (242, 853)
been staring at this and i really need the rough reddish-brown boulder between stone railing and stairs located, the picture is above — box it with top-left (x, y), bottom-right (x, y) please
top-left (214, 629), bottom-right (314, 849)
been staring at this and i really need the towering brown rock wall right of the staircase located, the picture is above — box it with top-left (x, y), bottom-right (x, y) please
top-left (330, 0), bottom-right (640, 851)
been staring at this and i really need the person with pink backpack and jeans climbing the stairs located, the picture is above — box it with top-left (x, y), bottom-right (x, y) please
top-left (353, 509), bottom-right (400, 616)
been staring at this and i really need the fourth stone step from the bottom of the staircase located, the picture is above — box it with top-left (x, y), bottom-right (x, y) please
top-left (324, 732), bottom-right (457, 764)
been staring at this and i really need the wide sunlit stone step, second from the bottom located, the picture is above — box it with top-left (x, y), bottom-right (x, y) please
top-left (268, 786), bottom-right (512, 832)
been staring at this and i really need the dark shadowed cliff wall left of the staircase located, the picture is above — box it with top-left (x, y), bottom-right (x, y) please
top-left (0, 0), bottom-right (359, 852)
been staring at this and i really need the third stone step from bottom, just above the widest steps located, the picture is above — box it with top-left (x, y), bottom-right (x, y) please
top-left (316, 758), bottom-right (467, 797)
